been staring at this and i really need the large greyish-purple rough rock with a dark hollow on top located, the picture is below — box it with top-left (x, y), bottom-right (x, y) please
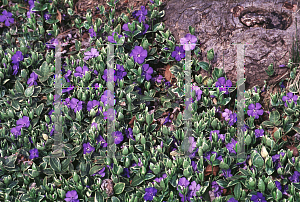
top-left (163, 0), bottom-right (300, 90)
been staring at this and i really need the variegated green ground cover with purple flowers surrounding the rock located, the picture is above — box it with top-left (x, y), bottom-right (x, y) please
top-left (0, 0), bottom-right (300, 202)
